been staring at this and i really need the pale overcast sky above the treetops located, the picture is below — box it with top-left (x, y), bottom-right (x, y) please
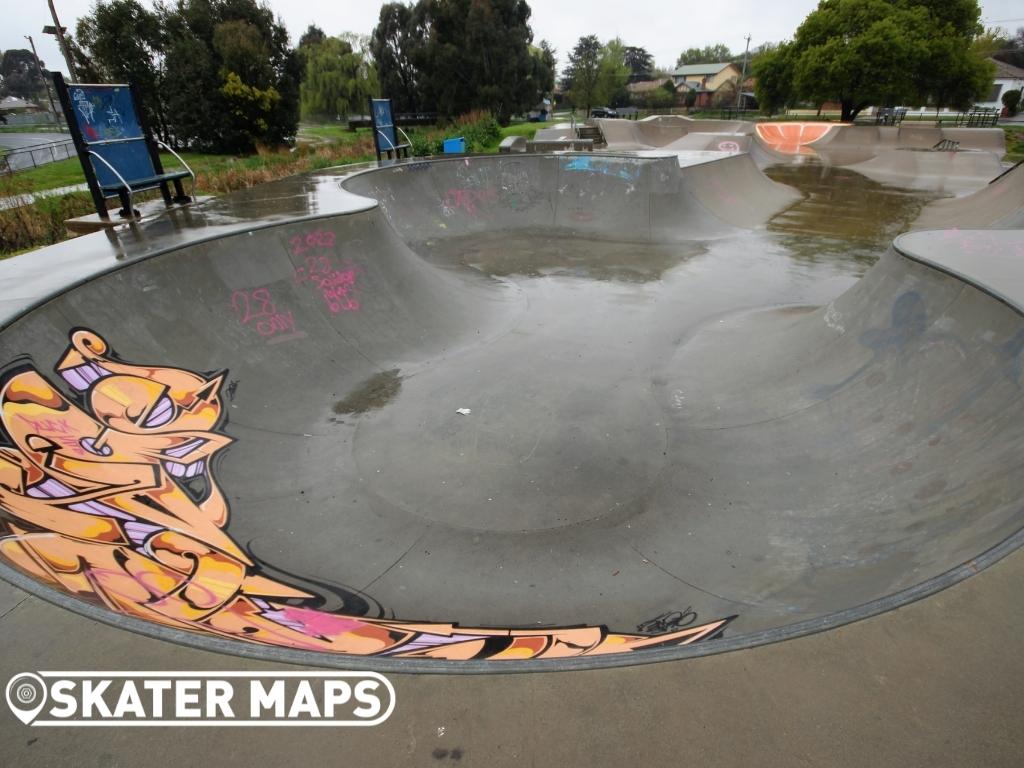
top-left (0, 0), bottom-right (1024, 74)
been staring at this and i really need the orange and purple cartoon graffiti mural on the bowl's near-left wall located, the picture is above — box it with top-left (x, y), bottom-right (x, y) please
top-left (0, 329), bottom-right (730, 659)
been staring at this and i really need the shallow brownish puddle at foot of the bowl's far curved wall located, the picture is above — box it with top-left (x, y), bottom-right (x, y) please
top-left (413, 230), bottom-right (708, 283)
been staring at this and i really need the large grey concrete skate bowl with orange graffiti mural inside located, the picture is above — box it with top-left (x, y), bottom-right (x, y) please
top-left (0, 155), bottom-right (1024, 672)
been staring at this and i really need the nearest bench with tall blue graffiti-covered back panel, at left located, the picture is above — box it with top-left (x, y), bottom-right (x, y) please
top-left (53, 72), bottom-right (196, 219)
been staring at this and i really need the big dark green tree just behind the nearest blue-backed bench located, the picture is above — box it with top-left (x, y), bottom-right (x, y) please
top-left (77, 0), bottom-right (301, 153)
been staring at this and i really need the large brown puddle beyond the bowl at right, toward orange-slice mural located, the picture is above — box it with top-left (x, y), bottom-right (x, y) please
top-left (765, 163), bottom-right (945, 267)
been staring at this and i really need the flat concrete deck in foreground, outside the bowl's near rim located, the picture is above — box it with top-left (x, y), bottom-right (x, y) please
top-left (0, 540), bottom-right (1024, 768)
